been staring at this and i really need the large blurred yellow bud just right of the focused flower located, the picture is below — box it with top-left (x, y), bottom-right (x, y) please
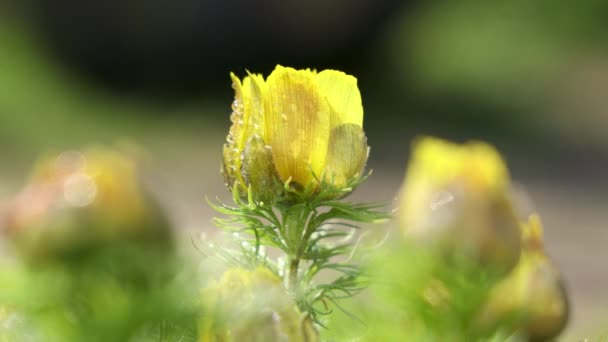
top-left (398, 137), bottom-right (520, 270)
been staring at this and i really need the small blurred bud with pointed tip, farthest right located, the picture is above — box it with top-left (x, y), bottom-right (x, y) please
top-left (479, 215), bottom-right (568, 341)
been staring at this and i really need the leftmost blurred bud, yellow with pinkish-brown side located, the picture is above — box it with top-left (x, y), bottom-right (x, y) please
top-left (0, 148), bottom-right (170, 260)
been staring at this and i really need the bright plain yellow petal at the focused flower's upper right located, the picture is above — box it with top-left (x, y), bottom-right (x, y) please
top-left (317, 70), bottom-right (363, 127)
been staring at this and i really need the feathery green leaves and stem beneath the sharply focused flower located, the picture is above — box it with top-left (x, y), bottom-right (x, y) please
top-left (211, 177), bottom-right (389, 324)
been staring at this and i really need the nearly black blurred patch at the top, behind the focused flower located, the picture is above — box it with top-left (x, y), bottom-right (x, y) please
top-left (23, 0), bottom-right (402, 89)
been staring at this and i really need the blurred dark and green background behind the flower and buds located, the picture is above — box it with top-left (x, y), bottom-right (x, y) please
top-left (0, 0), bottom-right (608, 341)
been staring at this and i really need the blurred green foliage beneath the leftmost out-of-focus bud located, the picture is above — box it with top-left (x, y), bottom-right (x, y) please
top-left (0, 243), bottom-right (199, 342)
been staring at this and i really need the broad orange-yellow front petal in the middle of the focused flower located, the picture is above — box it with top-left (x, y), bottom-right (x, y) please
top-left (264, 66), bottom-right (331, 186)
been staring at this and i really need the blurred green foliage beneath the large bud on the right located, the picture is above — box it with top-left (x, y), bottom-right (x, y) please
top-left (322, 241), bottom-right (520, 341)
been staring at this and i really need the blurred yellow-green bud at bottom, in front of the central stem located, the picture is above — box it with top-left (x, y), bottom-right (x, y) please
top-left (199, 267), bottom-right (318, 342)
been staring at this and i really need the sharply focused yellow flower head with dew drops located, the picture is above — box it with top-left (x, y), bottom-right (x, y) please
top-left (223, 65), bottom-right (368, 200)
